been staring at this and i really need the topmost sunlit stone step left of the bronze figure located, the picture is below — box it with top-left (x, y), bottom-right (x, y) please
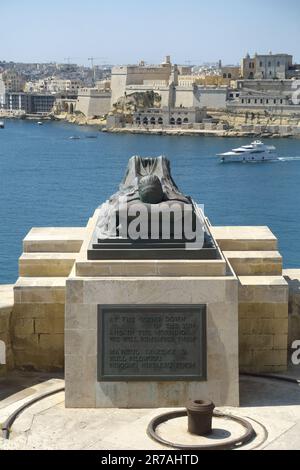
top-left (23, 227), bottom-right (86, 253)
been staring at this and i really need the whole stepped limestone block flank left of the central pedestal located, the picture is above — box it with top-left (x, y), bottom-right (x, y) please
top-left (10, 227), bottom-right (85, 371)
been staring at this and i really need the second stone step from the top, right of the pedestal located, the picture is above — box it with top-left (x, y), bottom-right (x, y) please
top-left (223, 251), bottom-right (282, 276)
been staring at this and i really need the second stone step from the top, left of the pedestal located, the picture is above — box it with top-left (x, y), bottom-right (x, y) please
top-left (19, 253), bottom-right (78, 277)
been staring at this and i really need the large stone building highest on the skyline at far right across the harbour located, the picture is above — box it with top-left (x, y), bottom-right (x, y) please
top-left (242, 52), bottom-right (293, 80)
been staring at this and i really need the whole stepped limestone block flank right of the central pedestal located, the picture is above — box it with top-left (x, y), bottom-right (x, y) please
top-left (213, 227), bottom-right (288, 373)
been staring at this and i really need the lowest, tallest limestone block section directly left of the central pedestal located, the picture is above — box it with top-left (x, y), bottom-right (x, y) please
top-left (11, 278), bottom-right (65, 371)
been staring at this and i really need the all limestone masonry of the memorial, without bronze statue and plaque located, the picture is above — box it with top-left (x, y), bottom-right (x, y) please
top-left (0, 211), bottom-right (300, 407)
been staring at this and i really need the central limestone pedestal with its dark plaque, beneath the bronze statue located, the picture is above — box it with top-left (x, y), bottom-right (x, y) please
top-left (65, 212), bottom-right (239, 408)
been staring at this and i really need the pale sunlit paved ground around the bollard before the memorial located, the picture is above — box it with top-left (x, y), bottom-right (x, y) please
top-left (0, 368), bottom-right (300, 450)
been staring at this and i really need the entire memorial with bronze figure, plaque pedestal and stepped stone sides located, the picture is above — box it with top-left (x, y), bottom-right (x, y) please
top-left (0, 157), bottom-right (290, 408)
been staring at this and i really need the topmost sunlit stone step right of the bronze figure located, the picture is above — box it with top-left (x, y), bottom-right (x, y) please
top-left (210, 227), bottom-right (277, 251)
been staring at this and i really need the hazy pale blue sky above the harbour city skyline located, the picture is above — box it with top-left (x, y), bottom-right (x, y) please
top-left (0, 0), bottom-right (300, 64)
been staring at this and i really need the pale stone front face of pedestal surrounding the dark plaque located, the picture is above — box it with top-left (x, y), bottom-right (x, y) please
top-left (65, 276), bottom-right (239, 408)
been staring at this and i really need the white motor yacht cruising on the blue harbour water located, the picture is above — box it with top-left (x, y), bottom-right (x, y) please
top-left (218, 140), bottom-right (278, 163)
